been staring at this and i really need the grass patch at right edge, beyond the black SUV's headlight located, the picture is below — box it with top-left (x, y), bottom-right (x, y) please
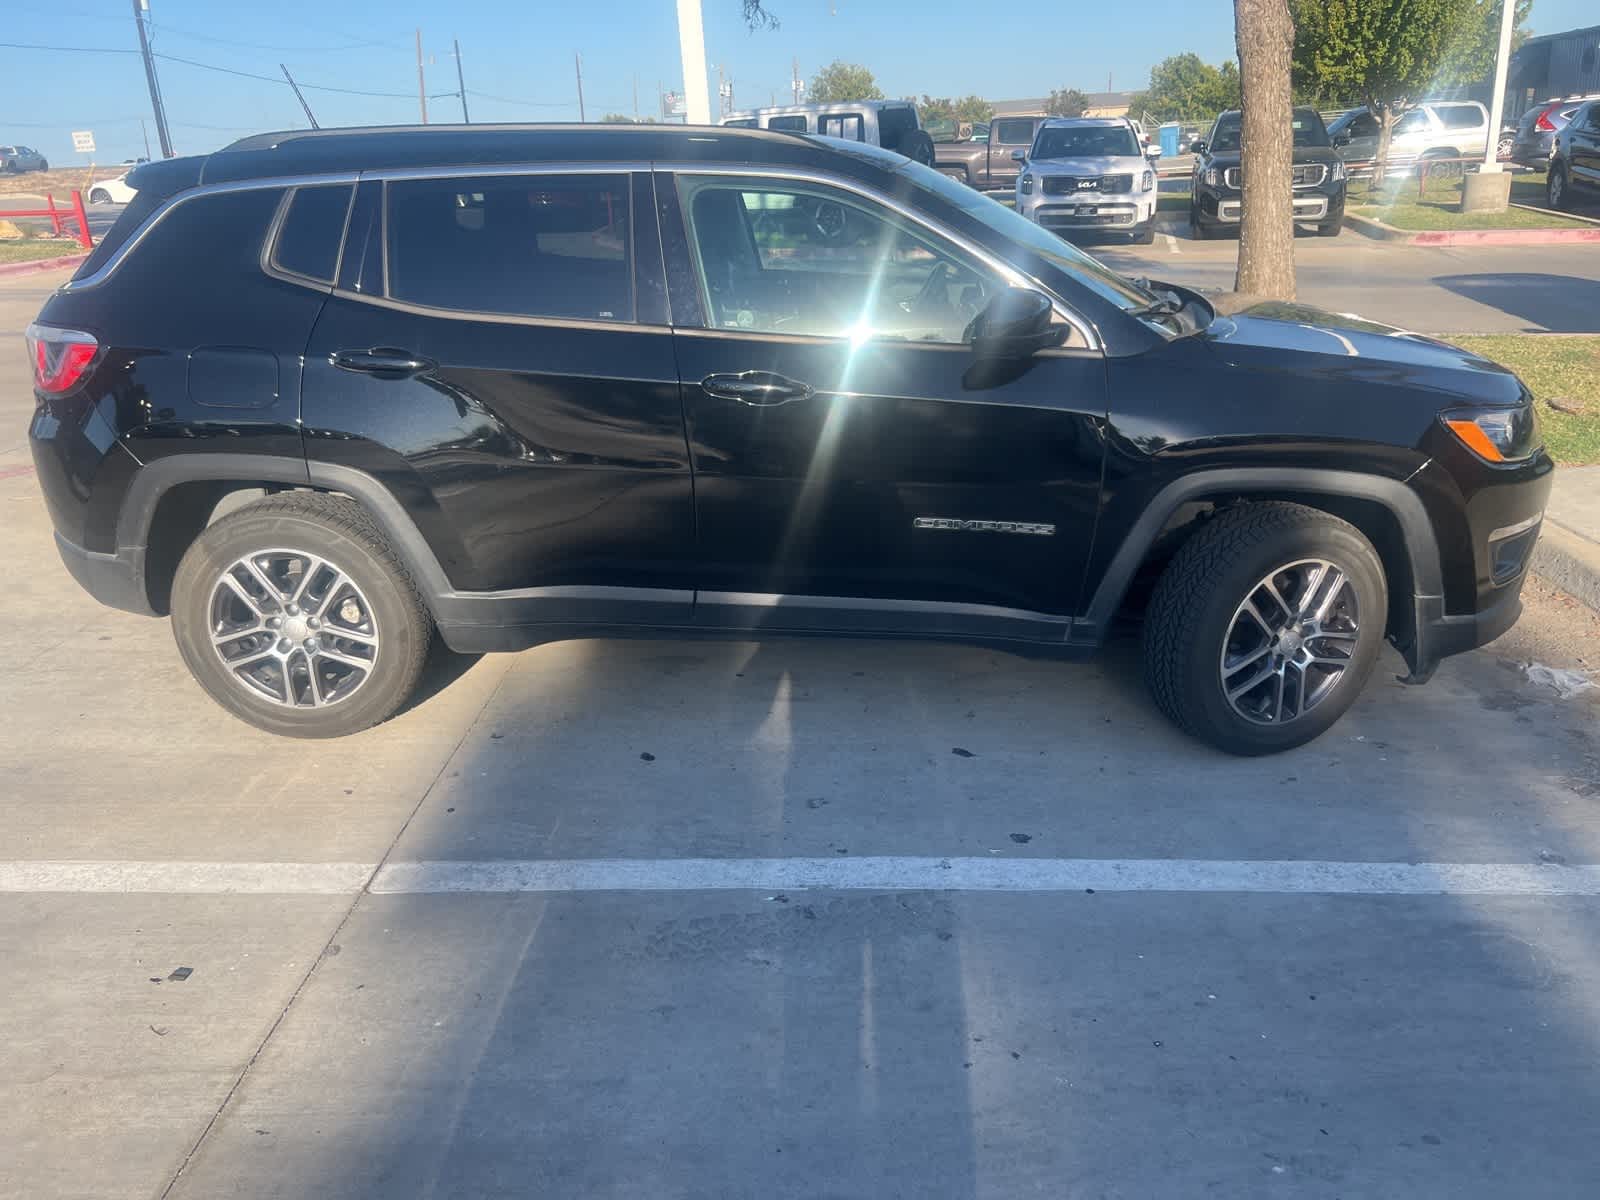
top-left (1448, 333), bottom-right (1600, 466)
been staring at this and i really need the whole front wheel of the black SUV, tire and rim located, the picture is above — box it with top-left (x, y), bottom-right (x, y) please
top-left (1144, 501), bottom-right (1389, 755)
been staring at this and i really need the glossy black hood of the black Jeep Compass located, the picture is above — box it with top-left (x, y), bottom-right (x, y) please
top-left (1203, 296), bottom-right (1526, 405)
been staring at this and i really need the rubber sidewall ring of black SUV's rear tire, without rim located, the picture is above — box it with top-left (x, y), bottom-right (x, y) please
top-left (171, 510), bottom-right (419, 738)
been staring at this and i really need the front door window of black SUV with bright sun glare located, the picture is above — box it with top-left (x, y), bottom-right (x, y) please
top-left (682, 179), bottom-right (1003, 344)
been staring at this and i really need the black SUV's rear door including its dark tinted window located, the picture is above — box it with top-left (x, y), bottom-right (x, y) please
top-left (302, 174), bottom-right (694, 621)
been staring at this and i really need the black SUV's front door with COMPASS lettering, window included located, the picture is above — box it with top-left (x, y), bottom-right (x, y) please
top-left (661, 179), bottom-right (1106, 640)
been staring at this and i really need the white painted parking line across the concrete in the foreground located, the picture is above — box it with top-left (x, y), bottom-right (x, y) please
top-left (0, 856), bottom-right (1600, 896)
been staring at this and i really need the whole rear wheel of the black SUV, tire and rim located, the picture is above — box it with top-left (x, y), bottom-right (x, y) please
top-left (173, 493), bottom-right (434, 738)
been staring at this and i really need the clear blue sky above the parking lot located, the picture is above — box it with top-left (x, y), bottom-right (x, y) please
top-left (0, 0), bottom-right (1595, 165)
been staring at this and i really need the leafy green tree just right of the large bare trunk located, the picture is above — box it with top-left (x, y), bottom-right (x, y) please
top-left (1290, 0), bottom-right (1494, 179)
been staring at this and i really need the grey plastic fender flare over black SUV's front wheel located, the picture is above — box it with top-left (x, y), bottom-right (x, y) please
top-left (1074, 467), bottom-right (1445, 638)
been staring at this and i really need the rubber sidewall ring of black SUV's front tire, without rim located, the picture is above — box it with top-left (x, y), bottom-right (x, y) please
top-left (1181, 522), bottom-right (1389, 755)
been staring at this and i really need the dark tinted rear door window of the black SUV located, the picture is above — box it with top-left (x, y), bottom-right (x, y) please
top-left (389, 174), bottom-right (634, 320)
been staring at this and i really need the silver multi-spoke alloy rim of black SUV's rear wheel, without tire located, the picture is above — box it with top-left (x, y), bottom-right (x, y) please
top-left (208, 549), bottom-right (379, 709)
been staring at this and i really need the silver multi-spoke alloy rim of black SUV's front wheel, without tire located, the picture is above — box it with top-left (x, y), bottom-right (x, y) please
top-left (1219, 558), bottom-right (1362, 725)
